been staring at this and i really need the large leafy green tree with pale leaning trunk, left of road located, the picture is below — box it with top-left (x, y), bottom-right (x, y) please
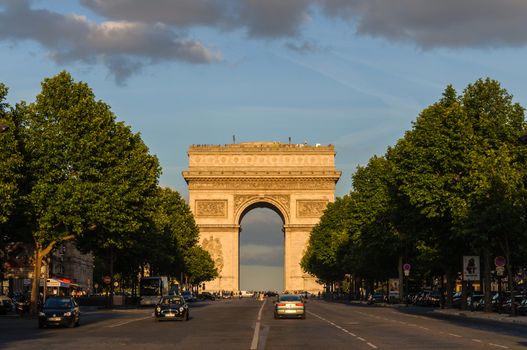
top-left (16, 72), bottom-right (159, 312)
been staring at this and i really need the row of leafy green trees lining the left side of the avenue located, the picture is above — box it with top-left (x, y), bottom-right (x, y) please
top-left (0, 72), bottom-right (217, 314)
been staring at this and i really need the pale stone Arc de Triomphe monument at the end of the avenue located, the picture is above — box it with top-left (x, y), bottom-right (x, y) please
top-left (183, 142), bottom-right (341, 292)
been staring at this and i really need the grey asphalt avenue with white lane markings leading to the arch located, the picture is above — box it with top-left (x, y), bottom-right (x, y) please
top-left (0, 299), bottom-right (527, 350)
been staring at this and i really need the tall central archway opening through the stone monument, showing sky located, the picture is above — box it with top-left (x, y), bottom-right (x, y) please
top-left (239, 203), bottom-right (284, 291)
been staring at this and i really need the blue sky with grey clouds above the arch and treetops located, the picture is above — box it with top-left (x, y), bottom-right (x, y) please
top-left (0, 0), bottom-right (527, 290)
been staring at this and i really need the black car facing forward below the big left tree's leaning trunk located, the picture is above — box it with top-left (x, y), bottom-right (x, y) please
top-left (38, 297), bottom-right (80, 328)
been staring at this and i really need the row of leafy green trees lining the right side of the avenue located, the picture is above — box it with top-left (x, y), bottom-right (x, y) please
top-left (302, 79), bottom-right (527, 307)
